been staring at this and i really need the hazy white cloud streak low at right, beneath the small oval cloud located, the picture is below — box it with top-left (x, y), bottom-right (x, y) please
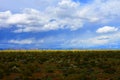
top-left (62, 32), bottom-right (120, 48)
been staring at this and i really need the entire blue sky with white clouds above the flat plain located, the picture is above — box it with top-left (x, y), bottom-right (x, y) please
top-left (0, 0), bottom-right (120, 49)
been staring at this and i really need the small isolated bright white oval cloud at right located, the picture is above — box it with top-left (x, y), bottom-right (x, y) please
top-left (96, 26), bottom-right (118, 33)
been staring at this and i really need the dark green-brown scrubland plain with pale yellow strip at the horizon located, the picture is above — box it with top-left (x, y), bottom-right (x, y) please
top-left (0, 50), bottom-right (120, 80)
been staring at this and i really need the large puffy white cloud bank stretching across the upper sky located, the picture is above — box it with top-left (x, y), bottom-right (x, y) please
top-left (0, 0), bottom-right (120, 33)
